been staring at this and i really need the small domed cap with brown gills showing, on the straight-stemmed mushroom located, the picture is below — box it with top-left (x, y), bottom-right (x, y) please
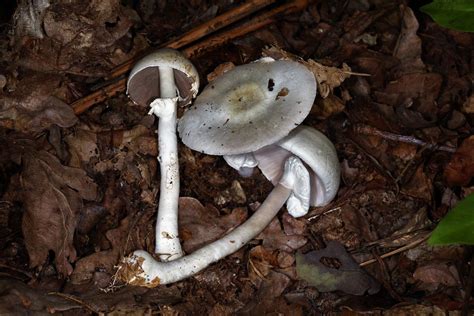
top-left (127, 48), bottom-right (199, 106)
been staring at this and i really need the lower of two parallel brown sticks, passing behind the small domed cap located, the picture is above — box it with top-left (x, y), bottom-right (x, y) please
top-left (71, 0), bottom-right (308, 114)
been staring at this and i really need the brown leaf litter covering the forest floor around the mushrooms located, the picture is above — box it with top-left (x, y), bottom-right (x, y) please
top-left (0, 0), bottom-right (474, 315)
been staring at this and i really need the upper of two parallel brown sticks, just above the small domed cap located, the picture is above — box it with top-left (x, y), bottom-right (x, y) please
top-left (105, 0), bottom-right (275, 80)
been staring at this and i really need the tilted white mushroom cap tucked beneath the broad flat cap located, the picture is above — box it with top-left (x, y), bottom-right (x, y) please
top-left (253, 125), bottom-right (341, 206)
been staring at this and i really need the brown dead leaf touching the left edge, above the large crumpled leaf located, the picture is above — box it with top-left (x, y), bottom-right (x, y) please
top-left (0, 74), bottom-right (77, 132)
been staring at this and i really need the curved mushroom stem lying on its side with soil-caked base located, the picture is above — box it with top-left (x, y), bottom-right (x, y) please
top-left (117, 156), bottom-right (309, 287)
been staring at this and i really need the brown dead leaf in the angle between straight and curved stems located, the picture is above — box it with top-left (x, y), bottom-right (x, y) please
top-left (179, 197), bottom-right (247, 253)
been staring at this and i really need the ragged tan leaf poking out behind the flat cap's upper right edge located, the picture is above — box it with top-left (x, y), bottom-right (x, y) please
top-left (262, 46), bottom-right (355, 98)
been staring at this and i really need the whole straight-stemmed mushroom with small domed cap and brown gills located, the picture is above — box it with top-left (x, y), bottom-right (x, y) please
top-left (127, 49), bottom-right (199, 261)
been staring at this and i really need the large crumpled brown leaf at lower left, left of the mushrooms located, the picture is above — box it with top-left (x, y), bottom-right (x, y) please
top-left (20, 150), bottom-right (97, 275)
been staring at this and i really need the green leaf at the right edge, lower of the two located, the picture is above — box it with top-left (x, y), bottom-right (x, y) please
top-left (428, 194), bottom-right (474, 245)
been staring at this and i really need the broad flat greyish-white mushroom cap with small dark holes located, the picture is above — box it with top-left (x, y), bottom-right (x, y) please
top-left (178, 60), bottom-right (317, 155)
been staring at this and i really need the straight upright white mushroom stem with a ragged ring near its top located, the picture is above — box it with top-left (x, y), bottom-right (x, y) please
top-left (150, 66), bottom-right (183, 261)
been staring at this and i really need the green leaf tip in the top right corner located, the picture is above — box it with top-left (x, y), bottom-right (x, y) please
top-left (420, 0), bottom-right (474, 32)
